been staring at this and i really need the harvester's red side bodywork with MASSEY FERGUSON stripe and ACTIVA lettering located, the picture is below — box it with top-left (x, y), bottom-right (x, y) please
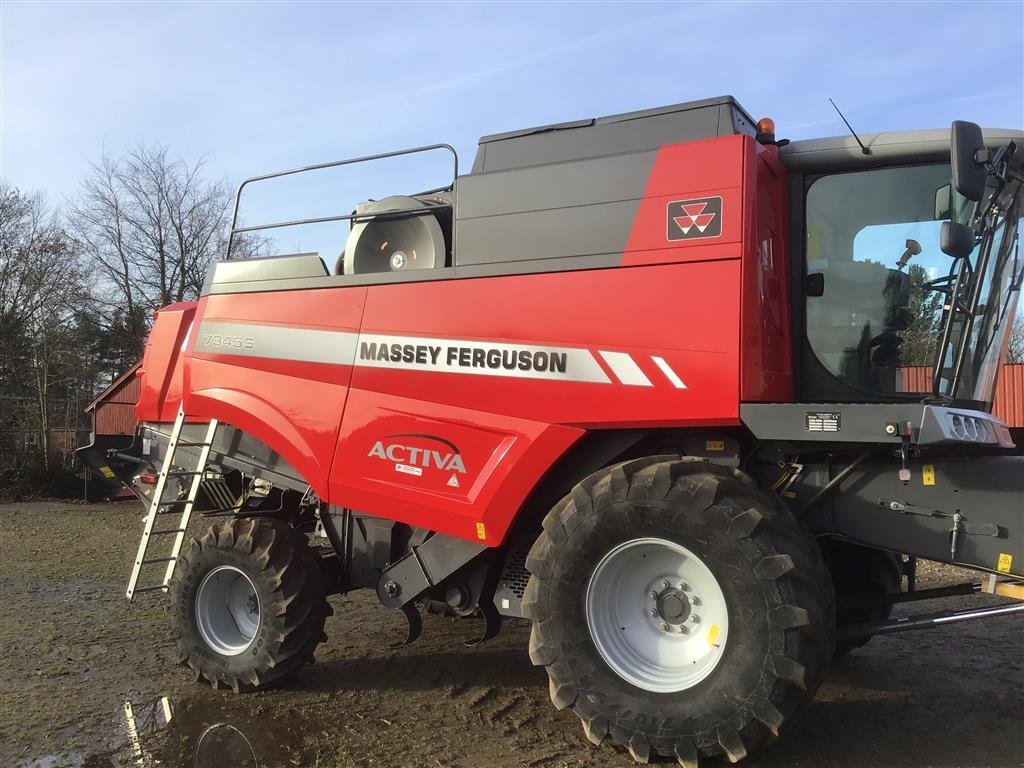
top-left (139, 136), bottom-right (792, 545)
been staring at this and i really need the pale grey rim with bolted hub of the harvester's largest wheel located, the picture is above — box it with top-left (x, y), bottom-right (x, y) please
top-left (586, 539), bottom-right (729, 693)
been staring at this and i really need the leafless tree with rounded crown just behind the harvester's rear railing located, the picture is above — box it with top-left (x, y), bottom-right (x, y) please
top-left (71, 144), bottom-right (230, 349)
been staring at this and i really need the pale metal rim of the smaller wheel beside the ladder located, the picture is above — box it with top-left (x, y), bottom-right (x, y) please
top-left (196, 565), bottom-right (260, 656)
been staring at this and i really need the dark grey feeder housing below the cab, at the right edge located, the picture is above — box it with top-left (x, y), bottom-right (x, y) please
top-left (805, 457), bottom-right (1024, 575)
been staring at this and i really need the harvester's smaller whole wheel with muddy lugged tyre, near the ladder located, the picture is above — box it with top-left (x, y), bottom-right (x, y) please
top-left (170, 519), bottom-right (332, 692)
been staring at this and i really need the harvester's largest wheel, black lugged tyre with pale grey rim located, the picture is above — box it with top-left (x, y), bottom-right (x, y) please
top-left (523, 457), bottom-right (835, 768)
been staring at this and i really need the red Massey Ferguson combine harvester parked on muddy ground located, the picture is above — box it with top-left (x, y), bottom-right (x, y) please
top-left (97, 97), bottom-right (1024, 766)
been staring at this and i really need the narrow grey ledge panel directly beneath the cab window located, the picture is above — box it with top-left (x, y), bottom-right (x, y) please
top-left (739, 402), bottom-right (1014, 447)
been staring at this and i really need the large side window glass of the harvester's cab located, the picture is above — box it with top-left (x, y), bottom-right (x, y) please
top-left (805, 164), bottom-right (951, 394)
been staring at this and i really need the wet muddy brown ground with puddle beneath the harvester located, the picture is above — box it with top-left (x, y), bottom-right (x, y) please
top-left (0, 502), bottom-right (1024, 768)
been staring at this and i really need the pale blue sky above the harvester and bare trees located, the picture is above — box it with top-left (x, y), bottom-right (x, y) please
top-left (0, 0), bottom-right (1024, 243)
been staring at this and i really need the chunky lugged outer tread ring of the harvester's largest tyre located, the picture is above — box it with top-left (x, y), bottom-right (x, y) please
top-left (523, 456), bottom-right (835, 768)
